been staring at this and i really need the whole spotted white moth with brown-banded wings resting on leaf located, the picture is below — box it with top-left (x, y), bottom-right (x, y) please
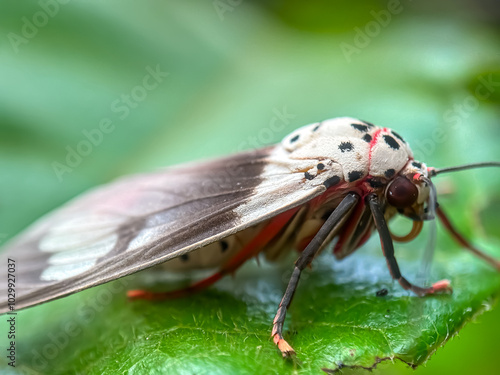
top-left (0, 117), bottom-right (500, 356)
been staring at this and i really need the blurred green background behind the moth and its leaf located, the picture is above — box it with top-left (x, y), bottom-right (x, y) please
top-left (0, 0), bottom-right (500, 374)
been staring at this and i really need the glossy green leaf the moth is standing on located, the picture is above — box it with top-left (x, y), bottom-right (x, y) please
top-left (3, 241), bottom-right (500, 374)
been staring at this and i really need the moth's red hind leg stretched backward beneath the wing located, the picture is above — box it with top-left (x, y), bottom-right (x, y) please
top-left (127, 207), bottom-right (300, 300)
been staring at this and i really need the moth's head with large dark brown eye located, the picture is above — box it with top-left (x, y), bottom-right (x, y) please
top-left (385, 161), bottom-right (436, 221)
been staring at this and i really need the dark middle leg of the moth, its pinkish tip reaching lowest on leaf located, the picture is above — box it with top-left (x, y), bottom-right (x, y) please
top-left (271, 193), bottom-right (359, 357)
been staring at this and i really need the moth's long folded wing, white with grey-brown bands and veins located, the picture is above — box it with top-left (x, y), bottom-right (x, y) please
top-left (0, 146), bottom-right (325, 313)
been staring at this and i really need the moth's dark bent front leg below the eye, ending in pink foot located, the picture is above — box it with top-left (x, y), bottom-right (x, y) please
top-left (368, 195), bottom-right (451, 296)
